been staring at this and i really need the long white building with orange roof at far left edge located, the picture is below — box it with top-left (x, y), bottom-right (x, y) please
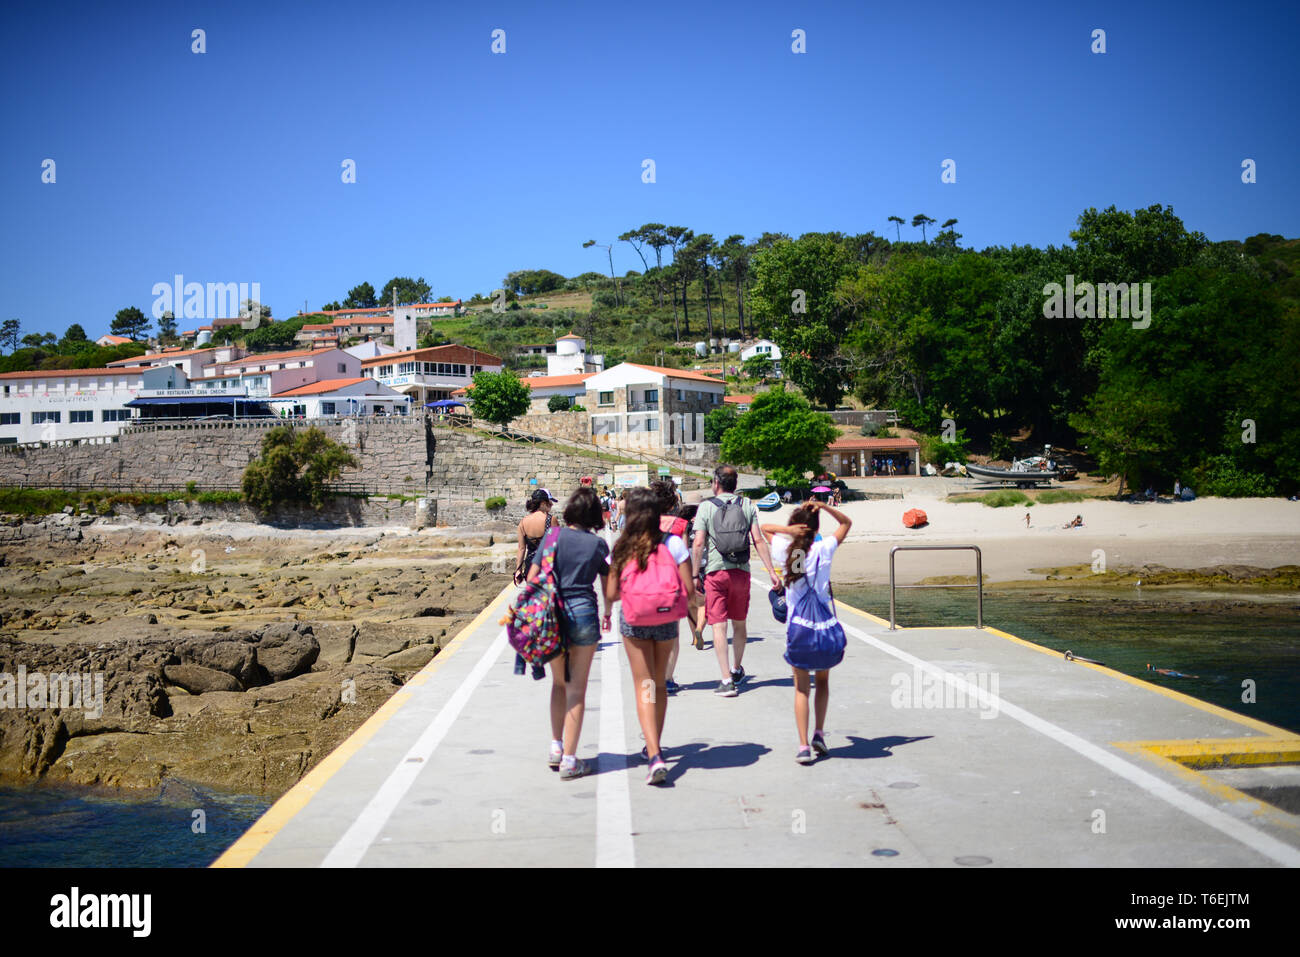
top-left (0, 365), bottom-right (189, 445)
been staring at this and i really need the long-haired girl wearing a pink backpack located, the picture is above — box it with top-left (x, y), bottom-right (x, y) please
top-left (603, 488), bottom-right (694, 784)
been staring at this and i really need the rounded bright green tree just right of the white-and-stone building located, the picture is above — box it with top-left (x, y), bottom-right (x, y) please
top-left (706, 386), bottom-right (840, 472)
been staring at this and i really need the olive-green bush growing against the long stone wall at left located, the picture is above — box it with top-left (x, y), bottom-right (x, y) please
top-left (242, 425), bottom-right (358, 511)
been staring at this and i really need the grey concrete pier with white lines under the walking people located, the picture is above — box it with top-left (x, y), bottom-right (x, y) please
top-left (217, 561), bottom-right (1300, 867)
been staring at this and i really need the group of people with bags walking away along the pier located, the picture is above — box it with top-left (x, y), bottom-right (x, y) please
top-left (515, 465), bottom-right (850, 784)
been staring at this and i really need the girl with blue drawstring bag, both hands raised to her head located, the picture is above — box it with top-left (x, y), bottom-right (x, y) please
top-left (764, 502), bottom-right (853, 765)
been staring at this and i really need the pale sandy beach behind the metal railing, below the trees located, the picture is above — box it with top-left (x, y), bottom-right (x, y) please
top-left (761, 494), bottom-right (1300, 584)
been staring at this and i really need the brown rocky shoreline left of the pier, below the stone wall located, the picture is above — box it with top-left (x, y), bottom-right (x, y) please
top-left (0, 514), bottom-right (514, 798)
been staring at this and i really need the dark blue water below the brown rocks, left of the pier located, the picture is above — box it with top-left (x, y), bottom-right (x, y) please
top-left (0, 785), bottom-right (269, 867)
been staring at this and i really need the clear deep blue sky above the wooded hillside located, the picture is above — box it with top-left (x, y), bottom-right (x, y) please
top-left (0, 0), bottom-right (1300, 337)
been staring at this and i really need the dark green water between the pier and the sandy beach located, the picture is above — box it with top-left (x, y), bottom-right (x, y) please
top-left (836, 585), bottom-right (1300, 732)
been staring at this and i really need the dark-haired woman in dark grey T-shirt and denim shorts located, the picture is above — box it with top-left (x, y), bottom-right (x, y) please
top-left (528, 488), bottom-right (610, 780)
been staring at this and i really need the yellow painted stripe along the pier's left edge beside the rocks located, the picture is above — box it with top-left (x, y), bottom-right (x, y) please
top-left (212, 585), bottom-right (514, 867)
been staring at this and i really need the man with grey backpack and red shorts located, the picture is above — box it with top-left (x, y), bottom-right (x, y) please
top-left (692, 465), bottom-right (781, 698)
